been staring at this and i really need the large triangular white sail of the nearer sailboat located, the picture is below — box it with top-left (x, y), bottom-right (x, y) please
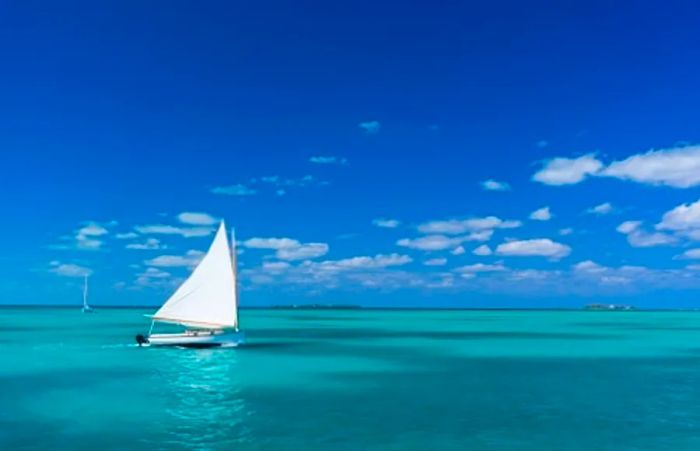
top-left (153, 221), bottom-right (238, 329)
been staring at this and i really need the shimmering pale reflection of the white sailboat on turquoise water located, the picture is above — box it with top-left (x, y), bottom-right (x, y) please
top-left (157, 349), bottom-right (251, 450)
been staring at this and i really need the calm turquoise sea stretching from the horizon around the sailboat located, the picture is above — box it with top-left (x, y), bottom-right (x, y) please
top-left (0, 309), bottom-right (700, 451)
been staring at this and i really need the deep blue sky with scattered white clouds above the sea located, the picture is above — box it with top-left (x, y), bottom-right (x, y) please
top-left (0, 1), bottom-right (700, 307)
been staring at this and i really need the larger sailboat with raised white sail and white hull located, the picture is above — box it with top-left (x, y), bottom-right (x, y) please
top-left (136, 221), bottom-right (244, 347)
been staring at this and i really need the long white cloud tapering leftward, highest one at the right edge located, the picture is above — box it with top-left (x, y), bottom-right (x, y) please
top-left (601, 145), bottom-right (700, 188)
